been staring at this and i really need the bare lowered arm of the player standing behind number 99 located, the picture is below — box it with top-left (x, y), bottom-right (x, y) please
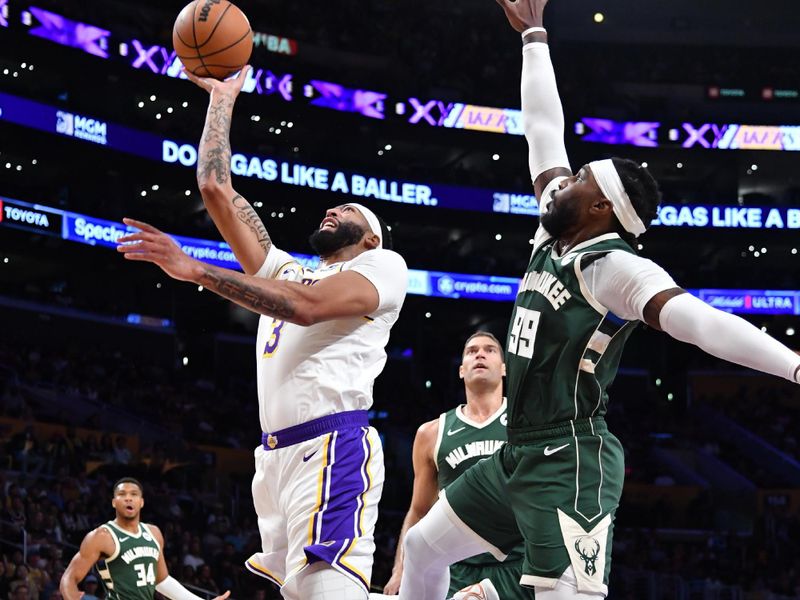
top-left (383, 419), bottom-right (439, 596)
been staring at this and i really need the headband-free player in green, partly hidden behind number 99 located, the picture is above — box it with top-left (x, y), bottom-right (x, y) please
top-left (383, 331), bottom-right (533, 600)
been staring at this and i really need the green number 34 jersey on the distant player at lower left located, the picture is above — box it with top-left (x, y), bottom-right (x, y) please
top-left (97, 521), bottom-right (161, 600)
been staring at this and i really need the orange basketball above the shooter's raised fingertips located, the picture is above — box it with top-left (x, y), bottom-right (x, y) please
top-left (172, 0), bottom-right (253, 79)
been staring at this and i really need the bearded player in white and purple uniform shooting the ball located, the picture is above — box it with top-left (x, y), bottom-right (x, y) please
top-left (119, 67), bottom-right (408, 600)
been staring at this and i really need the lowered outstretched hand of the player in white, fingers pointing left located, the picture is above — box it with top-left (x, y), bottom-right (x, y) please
top-left (117, 218), bottom-right (199, 281)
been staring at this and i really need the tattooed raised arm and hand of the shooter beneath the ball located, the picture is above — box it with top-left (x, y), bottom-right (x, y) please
top-left (185, 67), bottom-right (272, 275)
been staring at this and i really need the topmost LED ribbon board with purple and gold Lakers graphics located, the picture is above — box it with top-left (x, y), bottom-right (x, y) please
top-left (10, 0), bottom-right (800, 151)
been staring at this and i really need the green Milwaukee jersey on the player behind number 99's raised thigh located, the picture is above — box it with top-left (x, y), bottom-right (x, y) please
top-left (434, 399), bottom-right (524, 565)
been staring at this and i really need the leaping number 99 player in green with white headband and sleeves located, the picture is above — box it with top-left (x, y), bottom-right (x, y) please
top-left (374, 0), bottom-right (800, 600)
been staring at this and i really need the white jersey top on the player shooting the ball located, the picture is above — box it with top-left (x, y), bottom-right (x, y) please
top-left (256, 247), bottom-right (408, 432)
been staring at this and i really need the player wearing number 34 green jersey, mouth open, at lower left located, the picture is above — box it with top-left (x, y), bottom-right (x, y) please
top-left (60, 477), bottom-right (230, 600)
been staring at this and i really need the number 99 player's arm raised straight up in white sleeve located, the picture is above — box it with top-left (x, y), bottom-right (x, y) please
top-left (497, 0), bottom-right (572, 205)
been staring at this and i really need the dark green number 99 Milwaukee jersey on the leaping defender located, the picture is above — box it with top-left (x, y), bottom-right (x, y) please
top-left (506, 233), bottom-right (638, 429)
